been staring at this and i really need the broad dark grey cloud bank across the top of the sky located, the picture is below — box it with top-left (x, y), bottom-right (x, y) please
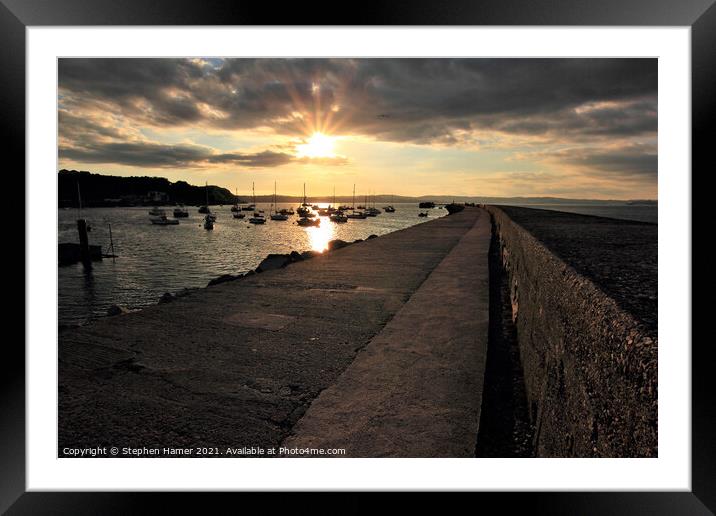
top-left (59, 59), bottom-right (657, 143)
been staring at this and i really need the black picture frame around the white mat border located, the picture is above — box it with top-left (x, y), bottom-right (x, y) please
top-left (0, 0), bottom-right (716, 514)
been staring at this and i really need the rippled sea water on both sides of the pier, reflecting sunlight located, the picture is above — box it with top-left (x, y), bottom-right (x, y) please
top-left (58, 203), bottom-right (657, 324)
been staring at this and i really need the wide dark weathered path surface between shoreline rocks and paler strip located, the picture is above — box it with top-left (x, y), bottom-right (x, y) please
top-left (59, 209), bottom-right (486, 455)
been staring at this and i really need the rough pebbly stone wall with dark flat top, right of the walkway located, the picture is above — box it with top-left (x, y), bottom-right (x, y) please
top-left (486, 206), bottom-right (658, 457)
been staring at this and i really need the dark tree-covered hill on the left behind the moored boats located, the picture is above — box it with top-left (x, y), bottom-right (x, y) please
top-left (57, 169), bottom-right (235, 208)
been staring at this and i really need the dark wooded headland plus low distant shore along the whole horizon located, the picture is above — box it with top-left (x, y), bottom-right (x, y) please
top-left (58, 169), bottom-right (658, 208)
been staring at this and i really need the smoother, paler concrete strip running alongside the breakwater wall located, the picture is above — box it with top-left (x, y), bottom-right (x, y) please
top-left (284, 209), bottom-right (491, 457)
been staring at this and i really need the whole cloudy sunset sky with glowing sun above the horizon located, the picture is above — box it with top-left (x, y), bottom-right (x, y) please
top-left (58, 58), bottom-right (657, 199)
